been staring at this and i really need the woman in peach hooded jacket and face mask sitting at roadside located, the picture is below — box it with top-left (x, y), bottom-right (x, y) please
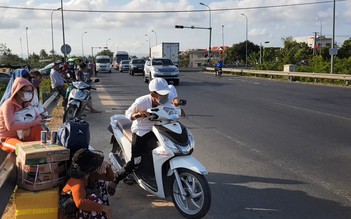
top-left (0, 77), bottom-right (46, 152)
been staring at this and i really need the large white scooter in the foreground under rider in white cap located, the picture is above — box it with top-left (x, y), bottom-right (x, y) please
top-left (108, 104), bottom-right (211, 218)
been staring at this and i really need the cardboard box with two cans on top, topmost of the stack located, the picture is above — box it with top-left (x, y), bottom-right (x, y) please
top-left (16, 141), bottom-right (70, 165)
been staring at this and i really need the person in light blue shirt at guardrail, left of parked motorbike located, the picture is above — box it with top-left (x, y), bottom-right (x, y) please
top-left (50, 62), bottom-right (67, 107)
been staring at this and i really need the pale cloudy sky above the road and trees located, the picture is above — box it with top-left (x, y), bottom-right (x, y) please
top-left (0, 0), bottom-right (351, 58)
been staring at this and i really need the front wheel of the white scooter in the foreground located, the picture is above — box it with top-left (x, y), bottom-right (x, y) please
top-left (172, 169), bottom-right (211, 218)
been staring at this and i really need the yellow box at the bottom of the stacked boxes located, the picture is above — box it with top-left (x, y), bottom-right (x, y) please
top-left (15, 187), bottom-right (59, 219)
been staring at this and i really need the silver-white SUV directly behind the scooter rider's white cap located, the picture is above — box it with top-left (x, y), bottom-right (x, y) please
top-left (144, 58), bottom-right (179, 85)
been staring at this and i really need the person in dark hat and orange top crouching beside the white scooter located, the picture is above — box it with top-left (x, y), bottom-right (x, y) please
top-left (61, 148), bottom-right (114, 218)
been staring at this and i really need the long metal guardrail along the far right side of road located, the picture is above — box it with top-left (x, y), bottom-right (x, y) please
top-left (206, 67), bottom-right (351, 85)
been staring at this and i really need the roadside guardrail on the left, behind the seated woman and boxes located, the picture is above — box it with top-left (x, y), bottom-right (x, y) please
top-left (0, 92), bottom-right (58, 215)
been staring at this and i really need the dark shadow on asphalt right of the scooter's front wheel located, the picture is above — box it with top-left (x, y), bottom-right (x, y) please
top-left (206, 173), bottom-right (351, 219)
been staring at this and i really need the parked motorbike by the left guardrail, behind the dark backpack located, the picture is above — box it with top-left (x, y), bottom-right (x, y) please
top-left (63, 75), bottom-right (100, 122)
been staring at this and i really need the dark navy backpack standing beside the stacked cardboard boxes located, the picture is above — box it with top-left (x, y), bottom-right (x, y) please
top-left (57, 118), bottom-right (90, 157)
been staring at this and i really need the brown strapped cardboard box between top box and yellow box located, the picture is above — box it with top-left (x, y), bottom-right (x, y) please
top-left (16, 158), bottom-right (67, 191)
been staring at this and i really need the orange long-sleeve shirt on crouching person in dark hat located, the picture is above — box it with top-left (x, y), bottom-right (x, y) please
top-left (62, 166), bottom-right (114, 212)
